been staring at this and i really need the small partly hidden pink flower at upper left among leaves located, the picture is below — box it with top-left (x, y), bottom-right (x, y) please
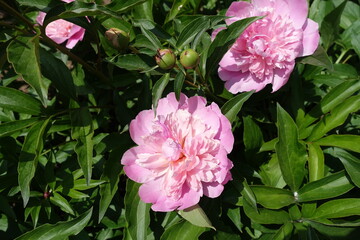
top-left (36, 0), bottom-right (85, 49)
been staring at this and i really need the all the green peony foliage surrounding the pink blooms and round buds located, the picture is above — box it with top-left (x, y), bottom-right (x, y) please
top-left (0, 0), bottom-right (360, 239)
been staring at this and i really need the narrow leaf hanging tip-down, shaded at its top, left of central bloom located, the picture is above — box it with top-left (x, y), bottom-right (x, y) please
top-left (70, 101), bottom-right (94, 185)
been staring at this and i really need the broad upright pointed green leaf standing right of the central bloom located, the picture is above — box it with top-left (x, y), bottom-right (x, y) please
top-left (275, 104), bottom-right (307, 192)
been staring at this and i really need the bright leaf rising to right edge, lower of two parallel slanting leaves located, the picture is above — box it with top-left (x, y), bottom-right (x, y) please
top-left (307, 95), bottom-right (360, 141)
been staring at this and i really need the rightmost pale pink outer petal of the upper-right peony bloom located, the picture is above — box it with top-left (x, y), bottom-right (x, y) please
top-left (301, 19), bottom-right (320, 56)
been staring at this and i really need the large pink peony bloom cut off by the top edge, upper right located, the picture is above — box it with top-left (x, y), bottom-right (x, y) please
top-left (215, 0), bottom-right (320, 93)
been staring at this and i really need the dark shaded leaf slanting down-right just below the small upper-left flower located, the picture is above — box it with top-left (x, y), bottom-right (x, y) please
top-left (40, 49), bottom-right (77, 100)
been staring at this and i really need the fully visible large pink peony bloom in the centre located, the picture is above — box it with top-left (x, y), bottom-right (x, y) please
top-left (121, 93), bottom-right (234, 212)
